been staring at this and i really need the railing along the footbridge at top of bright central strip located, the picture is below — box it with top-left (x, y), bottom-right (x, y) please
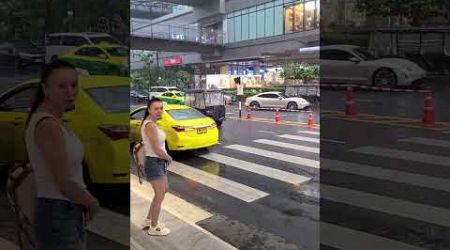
top-left (131, 21), bottom-right (224, 46)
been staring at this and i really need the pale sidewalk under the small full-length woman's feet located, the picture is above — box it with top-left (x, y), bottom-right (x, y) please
top-left (130, 175), bottom-right (237, 250)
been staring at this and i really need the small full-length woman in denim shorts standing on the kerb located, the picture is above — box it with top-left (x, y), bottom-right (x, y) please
top-left (141, 98), bottom-right (172, 236)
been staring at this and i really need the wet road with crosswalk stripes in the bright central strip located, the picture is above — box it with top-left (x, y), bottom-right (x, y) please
top-left (129, 111), bottom-right (320, 250)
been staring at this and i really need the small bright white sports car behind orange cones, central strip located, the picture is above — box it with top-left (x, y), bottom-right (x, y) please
top-left (245, 91), bottom-right (311, 110)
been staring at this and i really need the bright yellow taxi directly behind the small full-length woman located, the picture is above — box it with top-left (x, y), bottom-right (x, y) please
top-left (130, 104), bottom-right (219, 151)
